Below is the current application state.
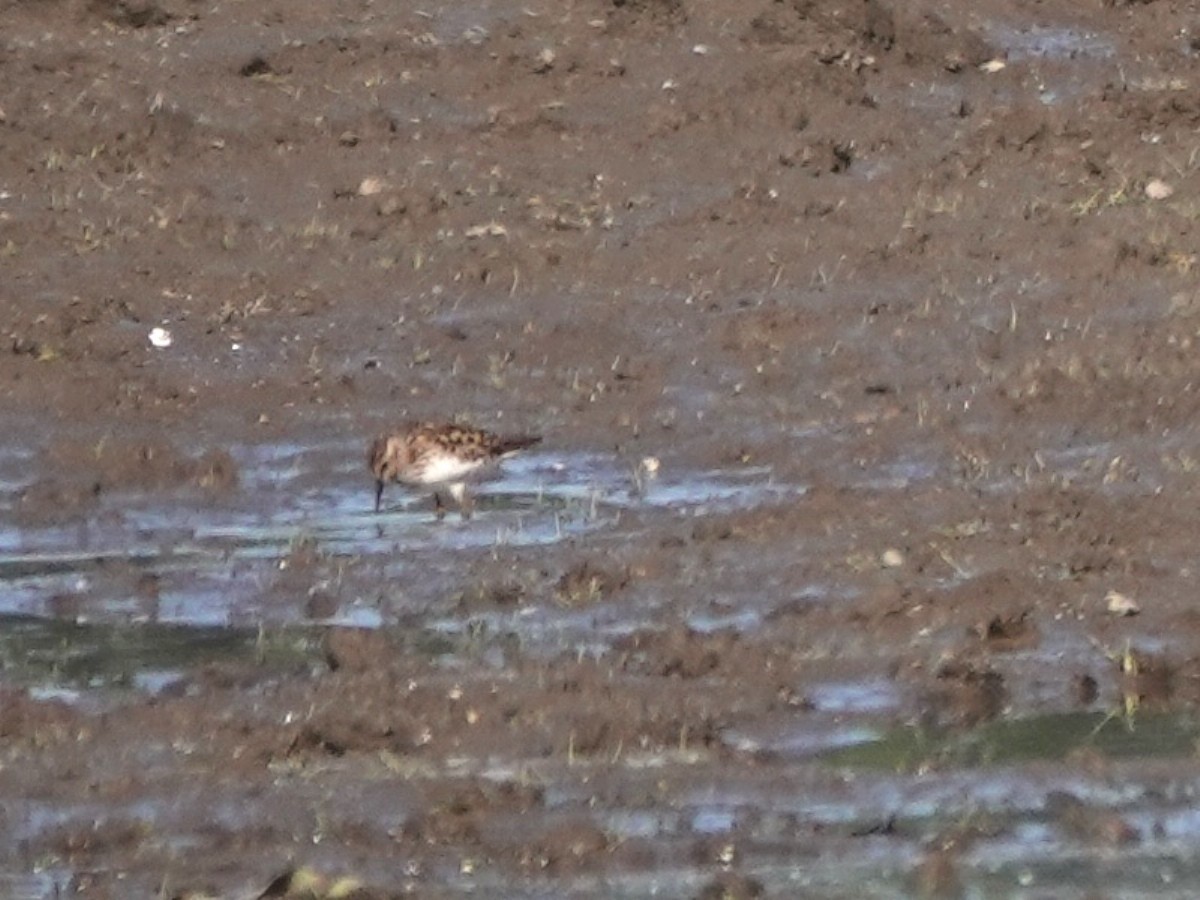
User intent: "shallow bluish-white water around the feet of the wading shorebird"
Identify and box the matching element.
[0,443,802,625]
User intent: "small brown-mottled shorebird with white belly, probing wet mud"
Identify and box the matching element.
[367,422,541,518]
